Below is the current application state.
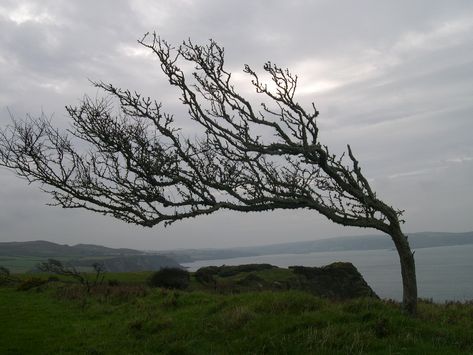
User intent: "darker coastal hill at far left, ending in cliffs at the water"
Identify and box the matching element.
[0,240,181,272]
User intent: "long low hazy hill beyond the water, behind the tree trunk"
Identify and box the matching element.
[160,232,473,263]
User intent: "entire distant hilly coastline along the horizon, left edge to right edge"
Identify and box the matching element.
[0,232,473,272]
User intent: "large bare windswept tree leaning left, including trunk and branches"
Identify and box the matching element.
[0,34,417,314]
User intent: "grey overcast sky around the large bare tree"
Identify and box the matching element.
[0,0,473,250]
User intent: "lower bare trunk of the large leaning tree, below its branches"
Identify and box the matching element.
[390,228,417,315]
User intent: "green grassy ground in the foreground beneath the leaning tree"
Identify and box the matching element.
[0,270,473,354]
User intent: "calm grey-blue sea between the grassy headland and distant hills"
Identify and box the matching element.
[182,244,473,303]
